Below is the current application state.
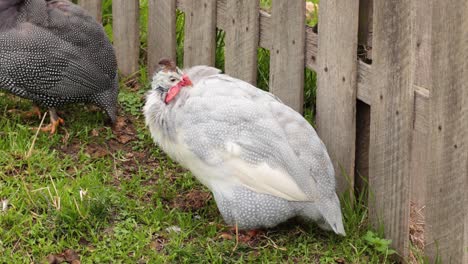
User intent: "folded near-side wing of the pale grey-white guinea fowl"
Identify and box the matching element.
[177,85,318,201]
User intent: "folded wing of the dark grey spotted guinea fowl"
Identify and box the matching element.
[0,23,112,97]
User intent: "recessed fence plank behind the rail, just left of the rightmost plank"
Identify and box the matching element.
[411,0,432,207]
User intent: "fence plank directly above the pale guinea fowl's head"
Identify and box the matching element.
[148,0,177,74]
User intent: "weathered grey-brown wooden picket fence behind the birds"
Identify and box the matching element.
[80,0,468,263]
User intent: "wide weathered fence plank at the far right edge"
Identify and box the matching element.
[425,0,468,263]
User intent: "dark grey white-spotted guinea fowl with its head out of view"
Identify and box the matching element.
[0,0,118,133]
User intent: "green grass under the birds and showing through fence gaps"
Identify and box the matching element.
[0,0,402,263]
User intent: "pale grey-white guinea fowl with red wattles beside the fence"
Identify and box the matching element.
[143,60,345,235]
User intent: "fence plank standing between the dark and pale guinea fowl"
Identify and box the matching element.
[112,0,140,75]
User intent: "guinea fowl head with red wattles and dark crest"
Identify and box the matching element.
[151,59,192,104]
